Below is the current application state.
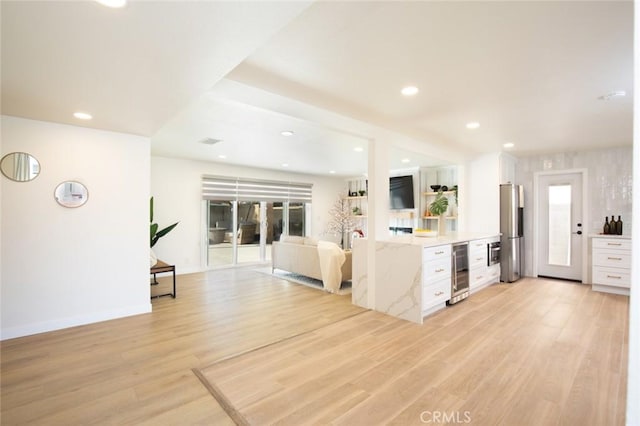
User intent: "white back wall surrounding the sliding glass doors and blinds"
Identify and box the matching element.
[151,156,347,274]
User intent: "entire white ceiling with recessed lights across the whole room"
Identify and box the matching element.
[1,1,633,175]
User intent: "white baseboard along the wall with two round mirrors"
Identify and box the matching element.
[0,302,151,340]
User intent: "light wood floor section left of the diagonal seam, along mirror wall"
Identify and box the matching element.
[0,269,363,425]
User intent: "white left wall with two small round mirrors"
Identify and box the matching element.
[0,116,151,339]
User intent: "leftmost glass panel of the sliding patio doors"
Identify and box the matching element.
[208,201,233,266]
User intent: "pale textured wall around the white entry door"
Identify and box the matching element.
[516,146,633,276]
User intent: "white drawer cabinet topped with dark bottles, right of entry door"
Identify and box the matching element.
[591,235,631,295]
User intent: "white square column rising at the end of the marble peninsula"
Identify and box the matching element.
[367,140,389,309]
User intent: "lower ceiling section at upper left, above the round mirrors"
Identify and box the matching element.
[0,0,309,136]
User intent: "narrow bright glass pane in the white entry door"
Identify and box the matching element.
[549,185,571,266]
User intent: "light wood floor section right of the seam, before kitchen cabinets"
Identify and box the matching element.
[200,280,627,426]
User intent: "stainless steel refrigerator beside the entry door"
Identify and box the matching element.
[500,183,524,283]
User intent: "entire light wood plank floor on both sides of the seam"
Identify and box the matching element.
[0,270,628,425]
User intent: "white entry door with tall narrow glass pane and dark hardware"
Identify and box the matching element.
[537,172,586,281]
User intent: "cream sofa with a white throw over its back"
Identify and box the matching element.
[271,235,351,287]
